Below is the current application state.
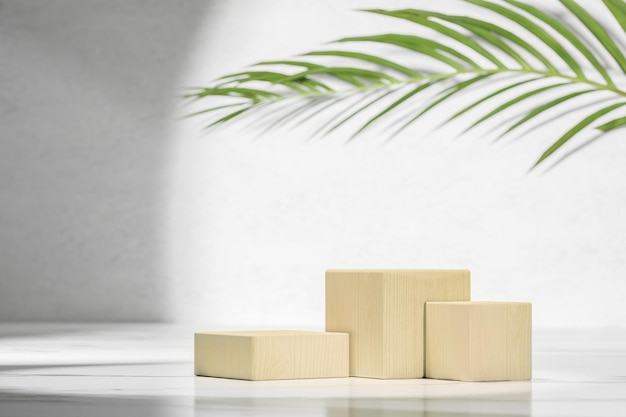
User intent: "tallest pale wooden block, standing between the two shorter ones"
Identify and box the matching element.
[326,269,470,379]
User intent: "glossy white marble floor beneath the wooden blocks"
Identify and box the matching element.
[0,324,626,417]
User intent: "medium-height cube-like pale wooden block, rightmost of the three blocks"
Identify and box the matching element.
[426,302,532,381]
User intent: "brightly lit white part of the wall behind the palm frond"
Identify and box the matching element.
[165,0,626,328]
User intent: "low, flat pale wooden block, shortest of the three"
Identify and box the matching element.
[194,330,349,381]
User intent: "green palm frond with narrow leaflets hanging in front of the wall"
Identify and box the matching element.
[184,0,626,166]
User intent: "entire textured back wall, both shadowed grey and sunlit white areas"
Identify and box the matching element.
[0,0,626,328]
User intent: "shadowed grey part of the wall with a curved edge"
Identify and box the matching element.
[0,0,206,321]
